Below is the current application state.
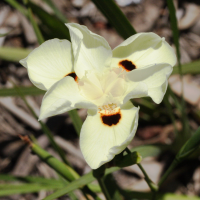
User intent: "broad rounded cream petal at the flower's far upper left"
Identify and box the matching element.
[20,39,73,90]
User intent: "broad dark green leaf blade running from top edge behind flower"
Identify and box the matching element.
[92,0,136,39]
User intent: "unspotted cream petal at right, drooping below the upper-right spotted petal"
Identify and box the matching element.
[127,63,173,104]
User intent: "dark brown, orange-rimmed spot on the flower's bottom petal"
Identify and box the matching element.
[101,111,121,126]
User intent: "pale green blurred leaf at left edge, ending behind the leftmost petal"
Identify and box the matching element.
[0,47,31,62]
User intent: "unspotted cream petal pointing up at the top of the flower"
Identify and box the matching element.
[66,23,112,78]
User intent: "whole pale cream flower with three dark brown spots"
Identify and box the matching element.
[20,23,176,169]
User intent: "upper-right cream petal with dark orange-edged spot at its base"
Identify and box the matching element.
[112,33,176,71]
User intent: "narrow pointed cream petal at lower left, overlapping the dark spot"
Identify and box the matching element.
[39,76,96,120]
